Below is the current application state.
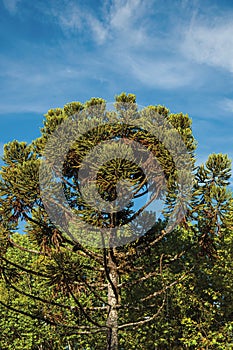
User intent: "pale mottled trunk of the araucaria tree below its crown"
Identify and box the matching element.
[107,250,119,350]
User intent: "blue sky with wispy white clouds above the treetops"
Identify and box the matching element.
[0,0,233,182]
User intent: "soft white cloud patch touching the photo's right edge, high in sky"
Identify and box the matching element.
[181,16,233,73]
